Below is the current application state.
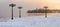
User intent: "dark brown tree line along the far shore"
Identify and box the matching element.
[27,9,60,13]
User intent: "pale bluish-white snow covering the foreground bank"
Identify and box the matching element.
[0,15,60,27]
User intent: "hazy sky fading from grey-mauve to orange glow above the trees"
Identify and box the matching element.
[0,0,60,17]
